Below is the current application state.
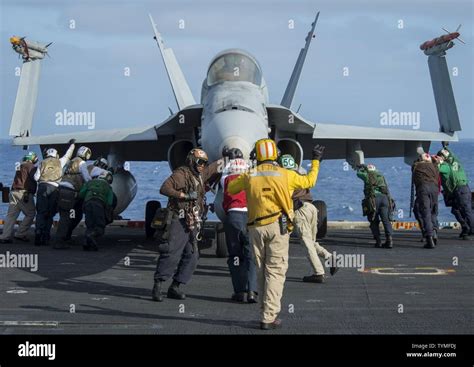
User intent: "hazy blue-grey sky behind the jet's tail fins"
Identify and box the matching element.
[0,0,474,138]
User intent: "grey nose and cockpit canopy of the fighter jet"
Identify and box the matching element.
[201,50,268,161]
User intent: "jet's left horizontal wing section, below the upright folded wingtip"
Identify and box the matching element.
[13,105,202,161]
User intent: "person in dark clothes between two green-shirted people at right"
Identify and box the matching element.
[412,153,439,249]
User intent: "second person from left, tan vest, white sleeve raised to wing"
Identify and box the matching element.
[34,139,75,246]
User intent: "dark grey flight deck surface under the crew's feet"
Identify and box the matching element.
[0,228,474,334]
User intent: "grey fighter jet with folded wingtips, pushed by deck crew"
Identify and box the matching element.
[10,12,461,253]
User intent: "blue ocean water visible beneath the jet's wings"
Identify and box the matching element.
[0,140,474,221]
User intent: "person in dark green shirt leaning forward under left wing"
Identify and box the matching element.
[79,172,114,251]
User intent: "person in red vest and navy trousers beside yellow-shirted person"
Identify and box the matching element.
[221,148,257,303]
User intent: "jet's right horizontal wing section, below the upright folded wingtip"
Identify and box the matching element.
[267,105,458,163]
